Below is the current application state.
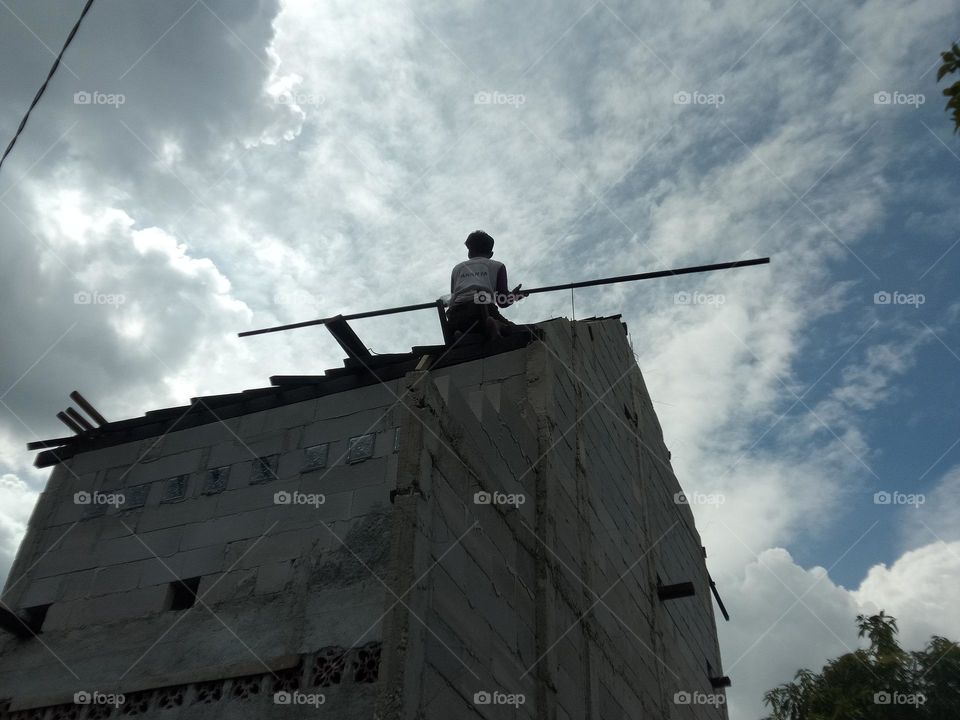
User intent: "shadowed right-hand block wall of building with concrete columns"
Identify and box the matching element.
[377,320,726,720]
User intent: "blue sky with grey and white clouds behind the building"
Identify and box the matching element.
[0,0,960,720]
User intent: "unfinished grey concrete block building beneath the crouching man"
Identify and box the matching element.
[0,317,728,720]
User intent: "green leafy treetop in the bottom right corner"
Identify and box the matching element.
[763,610,960,720]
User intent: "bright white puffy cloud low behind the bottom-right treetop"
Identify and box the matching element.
[719,542,960,720]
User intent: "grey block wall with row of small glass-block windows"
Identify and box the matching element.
[0,382,398,718]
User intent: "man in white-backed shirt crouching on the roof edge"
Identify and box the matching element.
[447,230,525,337]
